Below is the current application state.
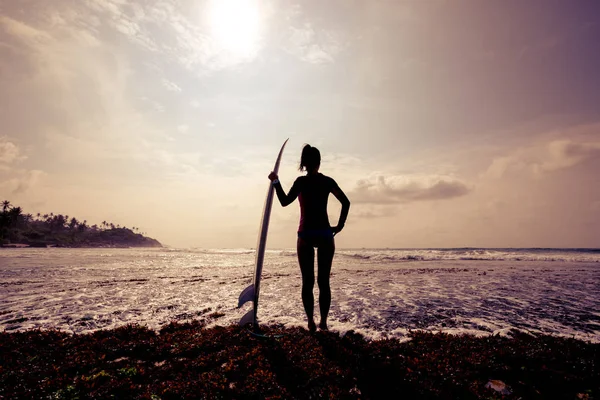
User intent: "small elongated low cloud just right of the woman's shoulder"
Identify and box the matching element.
[349,175,471,204]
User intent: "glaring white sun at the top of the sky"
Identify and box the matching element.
[208,0,260,57]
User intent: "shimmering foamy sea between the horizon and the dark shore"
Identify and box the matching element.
[0,248,600,342]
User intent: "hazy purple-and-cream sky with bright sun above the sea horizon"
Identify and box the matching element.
[0,0,600,248]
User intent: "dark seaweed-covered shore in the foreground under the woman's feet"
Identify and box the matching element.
[0,321,600,399]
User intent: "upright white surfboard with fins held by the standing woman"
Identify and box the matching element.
[238,139,289,330]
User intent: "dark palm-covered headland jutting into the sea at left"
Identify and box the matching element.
[0,200,162,247]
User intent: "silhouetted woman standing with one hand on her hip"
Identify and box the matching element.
[269,144,350,332]
